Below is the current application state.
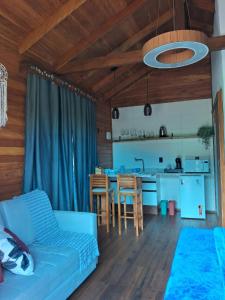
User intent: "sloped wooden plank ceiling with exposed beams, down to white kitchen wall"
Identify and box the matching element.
[0,0,215,106]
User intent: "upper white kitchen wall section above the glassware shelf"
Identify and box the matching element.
[112,99,212,138]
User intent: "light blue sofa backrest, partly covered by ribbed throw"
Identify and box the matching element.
[0,190,59,245]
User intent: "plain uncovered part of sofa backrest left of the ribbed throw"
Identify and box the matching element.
[0,197,34,245]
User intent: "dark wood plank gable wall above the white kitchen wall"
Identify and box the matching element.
[111,59,212,107]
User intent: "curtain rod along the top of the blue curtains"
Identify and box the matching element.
[27,65,97,102]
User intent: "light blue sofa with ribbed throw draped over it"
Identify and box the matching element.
[0,190,99,300]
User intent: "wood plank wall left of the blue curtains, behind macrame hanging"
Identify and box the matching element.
[0,37,26,200]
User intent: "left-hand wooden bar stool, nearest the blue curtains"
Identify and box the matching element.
[90,174,115,232]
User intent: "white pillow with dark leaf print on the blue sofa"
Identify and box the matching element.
[0,226,34,276]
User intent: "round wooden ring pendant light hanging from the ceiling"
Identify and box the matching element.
[143,30,209,69]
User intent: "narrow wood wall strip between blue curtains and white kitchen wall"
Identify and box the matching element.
[96,99,112,168]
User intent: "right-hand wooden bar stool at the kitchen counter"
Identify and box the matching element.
[117,175,143,236]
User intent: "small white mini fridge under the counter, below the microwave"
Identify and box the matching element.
[179,175,205,219]
